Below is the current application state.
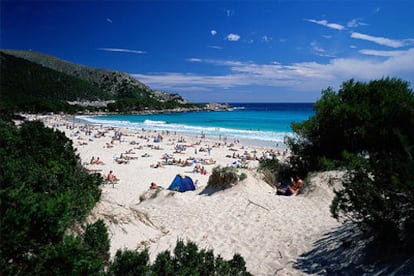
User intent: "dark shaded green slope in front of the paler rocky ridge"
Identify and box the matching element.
[0,52,111,111]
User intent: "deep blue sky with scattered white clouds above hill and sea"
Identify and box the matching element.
[0,0,414,102]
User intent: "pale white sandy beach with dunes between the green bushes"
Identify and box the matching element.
[29,116,341,275]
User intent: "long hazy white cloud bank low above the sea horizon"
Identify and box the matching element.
[132,48,414,92]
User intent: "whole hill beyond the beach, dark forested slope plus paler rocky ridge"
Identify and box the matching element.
[0,50,194,112]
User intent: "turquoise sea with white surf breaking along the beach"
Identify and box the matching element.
[77,103,314,147]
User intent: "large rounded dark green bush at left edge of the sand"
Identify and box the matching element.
[0,122,101,274]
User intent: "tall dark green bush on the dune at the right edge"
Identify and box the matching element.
[289,78,414,247]
